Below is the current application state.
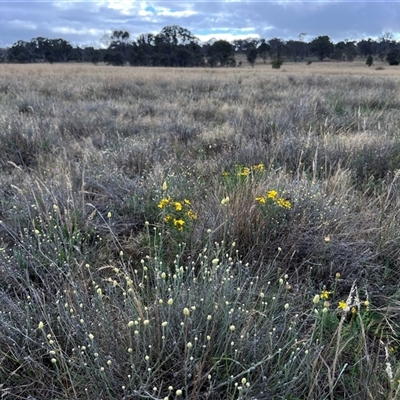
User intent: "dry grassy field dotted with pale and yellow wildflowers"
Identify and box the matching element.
[0,61,400,400]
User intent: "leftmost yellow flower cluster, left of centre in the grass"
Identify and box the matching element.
[157,197,197,231]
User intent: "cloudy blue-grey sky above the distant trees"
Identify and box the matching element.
[0,0,400,47]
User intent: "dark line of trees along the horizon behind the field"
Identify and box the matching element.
[0,25,400,68]
